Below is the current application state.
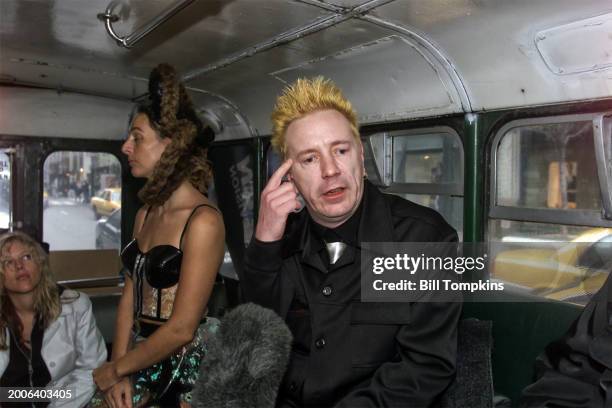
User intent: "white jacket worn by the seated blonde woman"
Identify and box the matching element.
[0,289,106,408]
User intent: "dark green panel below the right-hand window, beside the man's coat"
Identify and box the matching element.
[463,296,582,406]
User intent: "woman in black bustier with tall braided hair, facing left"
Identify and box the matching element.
[93,64,225,407]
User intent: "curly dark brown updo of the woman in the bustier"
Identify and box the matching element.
[135,64,215,206]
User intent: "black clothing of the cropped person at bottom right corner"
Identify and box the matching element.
[521,274,612,408]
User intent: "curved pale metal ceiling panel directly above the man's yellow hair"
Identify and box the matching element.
[190,16,462,134]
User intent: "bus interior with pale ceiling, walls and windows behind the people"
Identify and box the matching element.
[0,0,612,401]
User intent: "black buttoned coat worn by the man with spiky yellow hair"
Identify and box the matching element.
[240,182,461,407]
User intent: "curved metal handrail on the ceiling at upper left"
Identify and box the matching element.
[98,0,195,48]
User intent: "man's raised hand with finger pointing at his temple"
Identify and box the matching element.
[255,159,301,242]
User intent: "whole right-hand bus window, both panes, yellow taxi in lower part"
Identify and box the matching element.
[489,116,612,303]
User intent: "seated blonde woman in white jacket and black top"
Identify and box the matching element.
[0,232,106,407]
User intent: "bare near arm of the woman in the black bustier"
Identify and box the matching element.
[96,207,225,389]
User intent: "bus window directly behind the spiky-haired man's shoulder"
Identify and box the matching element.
[368,128,463,238]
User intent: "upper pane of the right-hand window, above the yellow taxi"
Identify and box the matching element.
[496,121,601,210]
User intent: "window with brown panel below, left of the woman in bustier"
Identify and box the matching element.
[43,151,121,280]
